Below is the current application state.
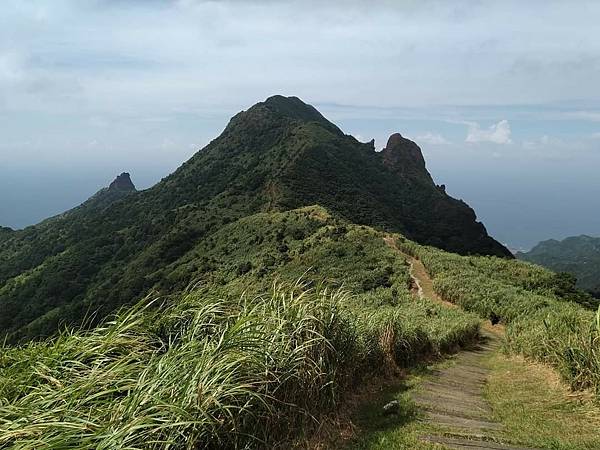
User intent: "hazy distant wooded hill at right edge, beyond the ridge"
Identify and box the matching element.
[517,235,600,295]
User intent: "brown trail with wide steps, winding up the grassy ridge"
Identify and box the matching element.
[385,236,531,450]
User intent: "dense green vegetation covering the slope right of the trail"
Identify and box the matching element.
[400,237,600,395]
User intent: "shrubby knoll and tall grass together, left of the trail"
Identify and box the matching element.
[0,214,479,449]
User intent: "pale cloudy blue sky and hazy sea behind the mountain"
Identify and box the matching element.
[0,0,600,249]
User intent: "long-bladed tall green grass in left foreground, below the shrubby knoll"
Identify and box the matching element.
[0,286,477,450]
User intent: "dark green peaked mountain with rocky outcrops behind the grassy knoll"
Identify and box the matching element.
[0,96,510,339]
